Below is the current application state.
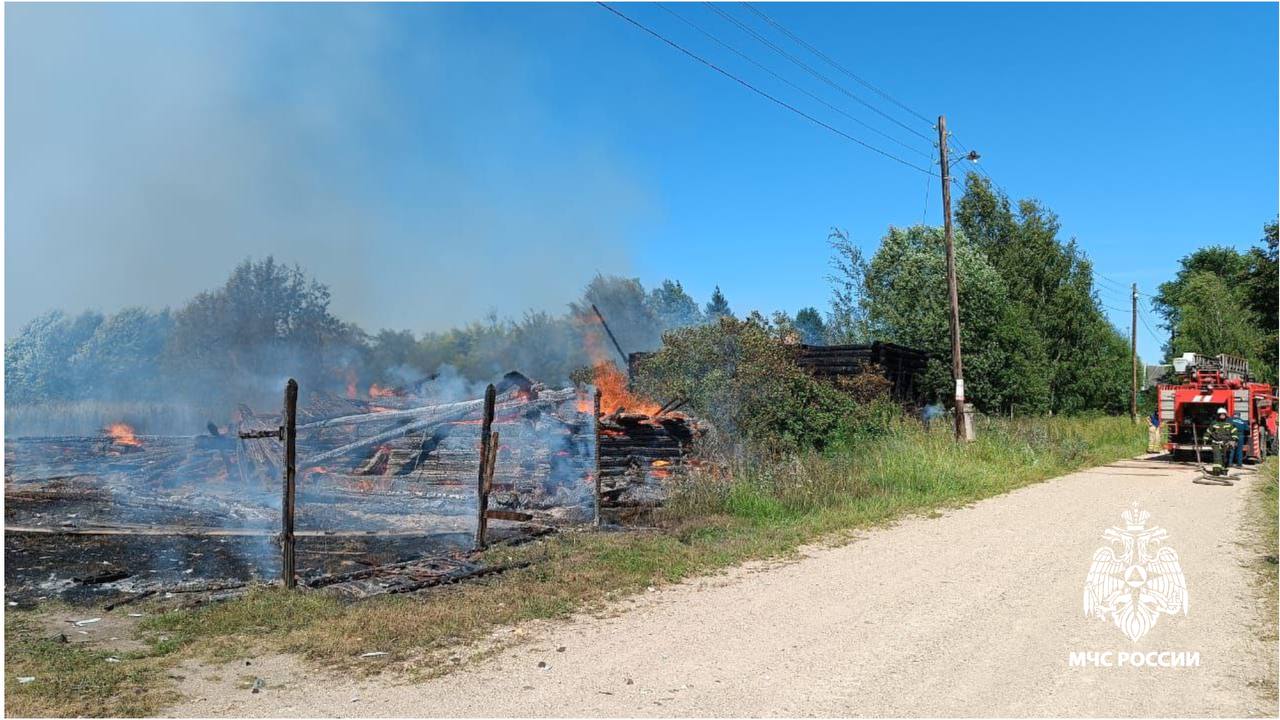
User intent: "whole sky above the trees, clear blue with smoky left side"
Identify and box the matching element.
[5,4,1277,359]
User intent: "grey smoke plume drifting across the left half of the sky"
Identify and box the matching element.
[5,5,646,334]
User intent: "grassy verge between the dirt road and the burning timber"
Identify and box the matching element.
[5,418,1146,715]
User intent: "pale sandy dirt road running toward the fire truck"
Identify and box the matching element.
[170,460,1277,716]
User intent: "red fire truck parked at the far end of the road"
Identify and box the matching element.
[1156,352,1276,461]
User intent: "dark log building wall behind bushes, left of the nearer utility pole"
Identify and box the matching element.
[795,341,928,405]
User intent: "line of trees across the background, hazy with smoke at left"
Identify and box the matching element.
[5,174,1276,425]
